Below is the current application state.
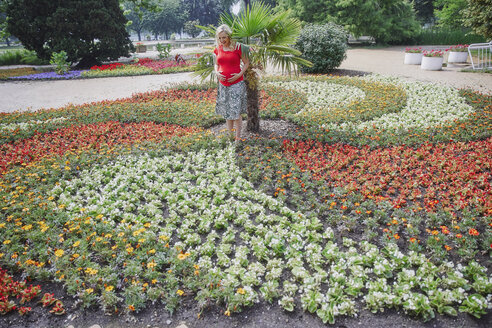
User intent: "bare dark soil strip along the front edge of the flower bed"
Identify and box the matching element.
[0,272,492,328]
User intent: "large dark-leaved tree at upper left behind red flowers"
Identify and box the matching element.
[7,0,134,67]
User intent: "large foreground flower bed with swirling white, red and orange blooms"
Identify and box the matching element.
[0,75,492,323]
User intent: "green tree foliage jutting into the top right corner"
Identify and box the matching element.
[463,0,492,40]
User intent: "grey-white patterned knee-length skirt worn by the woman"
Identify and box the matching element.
[215,81,247,120]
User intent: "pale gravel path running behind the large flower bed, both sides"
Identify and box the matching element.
[0,46,492,112]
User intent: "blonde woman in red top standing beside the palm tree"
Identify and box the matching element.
[214,25,249,141]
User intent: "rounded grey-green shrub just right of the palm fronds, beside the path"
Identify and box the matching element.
[296,23,348,73]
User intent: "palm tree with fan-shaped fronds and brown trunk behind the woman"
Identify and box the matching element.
[196,2,312,132]
